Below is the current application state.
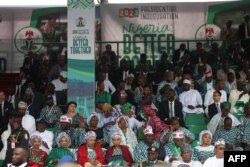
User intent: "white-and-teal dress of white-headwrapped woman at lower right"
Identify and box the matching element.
[194,145,214,162]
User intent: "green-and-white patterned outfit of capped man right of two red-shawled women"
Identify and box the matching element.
[134,141,160,162]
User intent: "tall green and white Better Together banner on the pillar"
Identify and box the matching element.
[68,0,95,118]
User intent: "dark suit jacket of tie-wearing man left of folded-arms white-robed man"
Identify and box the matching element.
[158,100,185,127]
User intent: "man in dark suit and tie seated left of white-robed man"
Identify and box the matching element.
[158,88,185,126]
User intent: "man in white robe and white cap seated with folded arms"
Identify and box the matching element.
[179,79,204,115]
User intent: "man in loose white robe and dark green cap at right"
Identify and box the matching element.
[207,102,241,134]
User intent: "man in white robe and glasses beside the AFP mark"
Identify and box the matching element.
[202,139,226,167]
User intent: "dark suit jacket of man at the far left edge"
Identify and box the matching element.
[0,101,13,134]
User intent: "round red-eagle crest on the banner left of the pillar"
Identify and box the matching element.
[14,27,43,54]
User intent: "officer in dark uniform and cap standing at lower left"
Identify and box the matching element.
[3,110,29,167]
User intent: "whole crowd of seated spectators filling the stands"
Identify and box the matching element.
[0,42,250,167]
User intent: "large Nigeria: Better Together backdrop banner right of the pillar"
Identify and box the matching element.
[101,1,250,65]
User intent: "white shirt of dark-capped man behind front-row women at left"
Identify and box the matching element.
[31,130,54,153]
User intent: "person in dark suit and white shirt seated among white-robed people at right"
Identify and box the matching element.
[205,90,221,119]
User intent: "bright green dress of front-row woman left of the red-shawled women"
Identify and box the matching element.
[45,147,73,167]
